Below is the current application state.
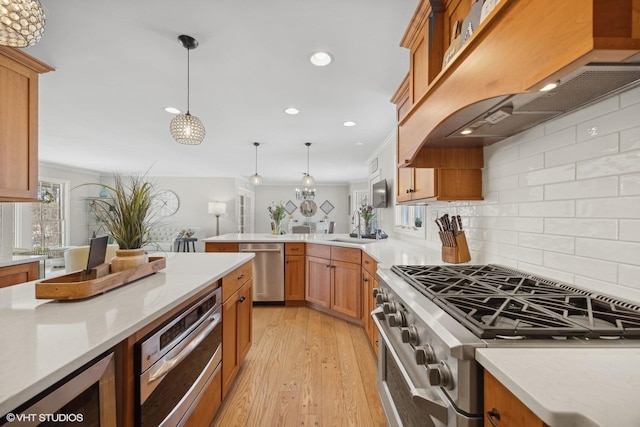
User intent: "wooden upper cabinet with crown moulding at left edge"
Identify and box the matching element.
[0,46,53,202]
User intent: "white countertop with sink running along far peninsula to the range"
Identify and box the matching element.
[203,233,442,268]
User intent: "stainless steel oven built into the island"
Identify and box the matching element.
[135,287,222,427]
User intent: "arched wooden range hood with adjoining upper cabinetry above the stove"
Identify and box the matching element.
[393,0,640,167]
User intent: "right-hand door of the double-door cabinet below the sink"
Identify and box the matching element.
[331,261,362,319]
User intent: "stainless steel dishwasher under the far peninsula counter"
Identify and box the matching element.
[240,243,284,303]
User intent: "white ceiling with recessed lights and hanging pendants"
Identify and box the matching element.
[25,0,418,184]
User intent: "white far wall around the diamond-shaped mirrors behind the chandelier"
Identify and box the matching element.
[254,185,351,233]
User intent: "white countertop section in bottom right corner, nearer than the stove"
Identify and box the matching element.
[476,348,640,427]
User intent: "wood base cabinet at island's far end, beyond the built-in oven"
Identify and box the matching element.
[221,262,253,399]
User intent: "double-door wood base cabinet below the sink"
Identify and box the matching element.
[305,244,362,320]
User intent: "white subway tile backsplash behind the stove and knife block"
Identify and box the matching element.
[390,89,640,302]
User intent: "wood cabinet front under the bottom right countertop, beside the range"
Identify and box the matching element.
[484,371,548,427]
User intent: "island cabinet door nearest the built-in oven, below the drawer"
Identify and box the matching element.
[222,293,239,399]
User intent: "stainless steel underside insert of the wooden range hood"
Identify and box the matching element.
[445,63,640,145]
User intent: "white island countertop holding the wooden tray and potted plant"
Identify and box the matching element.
[0,253,254,415]
